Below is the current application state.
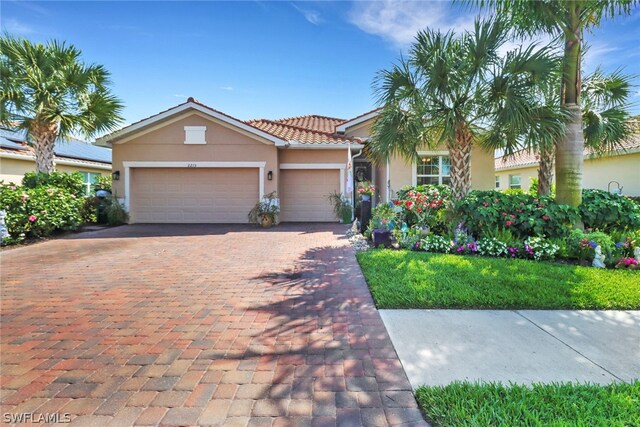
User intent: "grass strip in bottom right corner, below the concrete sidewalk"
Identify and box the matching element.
[416,381,640,427]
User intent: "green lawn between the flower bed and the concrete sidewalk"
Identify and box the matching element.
[357,249,640,310]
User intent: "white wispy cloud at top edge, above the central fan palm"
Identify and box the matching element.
[348,0,475,47]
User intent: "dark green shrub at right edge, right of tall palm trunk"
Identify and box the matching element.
[579,190,640,232]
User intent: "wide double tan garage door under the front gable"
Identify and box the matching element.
[131,168,259,223]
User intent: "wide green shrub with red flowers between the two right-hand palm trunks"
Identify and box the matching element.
[456,191,579,239]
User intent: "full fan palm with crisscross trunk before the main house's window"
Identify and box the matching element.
[367,20,563,199]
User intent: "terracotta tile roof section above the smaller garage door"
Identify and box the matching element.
[246,116,362,144]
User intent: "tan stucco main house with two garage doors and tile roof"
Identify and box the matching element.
[96,98,494,223]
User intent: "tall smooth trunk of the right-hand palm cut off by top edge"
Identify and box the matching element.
[556,2,584,206]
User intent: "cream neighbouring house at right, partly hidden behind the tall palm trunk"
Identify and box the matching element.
[495,135,640,197]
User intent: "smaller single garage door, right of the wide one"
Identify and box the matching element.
[280,169,340,222]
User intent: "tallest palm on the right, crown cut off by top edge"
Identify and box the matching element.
[469,0,637,206]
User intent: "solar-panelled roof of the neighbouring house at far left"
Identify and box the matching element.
[0,129,111,165]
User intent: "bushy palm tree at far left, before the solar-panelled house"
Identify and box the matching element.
[0,36,122,173]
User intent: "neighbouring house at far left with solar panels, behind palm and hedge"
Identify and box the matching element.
[0,129,111,194]
